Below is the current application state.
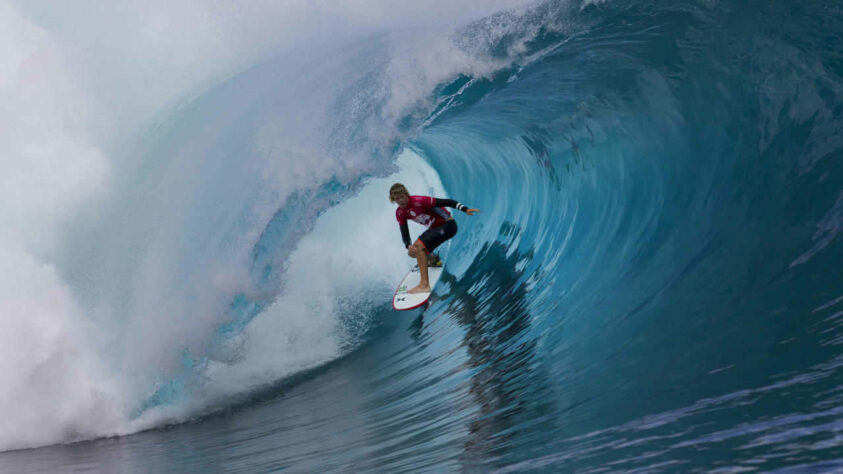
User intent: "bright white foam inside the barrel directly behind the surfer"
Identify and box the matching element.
[191,151,445,406]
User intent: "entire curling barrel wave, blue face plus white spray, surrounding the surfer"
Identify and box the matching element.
[0,1,843,470]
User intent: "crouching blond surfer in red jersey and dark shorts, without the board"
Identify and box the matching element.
[389,183,480,293]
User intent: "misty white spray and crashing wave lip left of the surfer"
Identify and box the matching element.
[0,2,540,449]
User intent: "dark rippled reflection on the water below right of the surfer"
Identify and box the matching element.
[437,224,556,470]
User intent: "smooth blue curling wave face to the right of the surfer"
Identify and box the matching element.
[412,2,843,470]
